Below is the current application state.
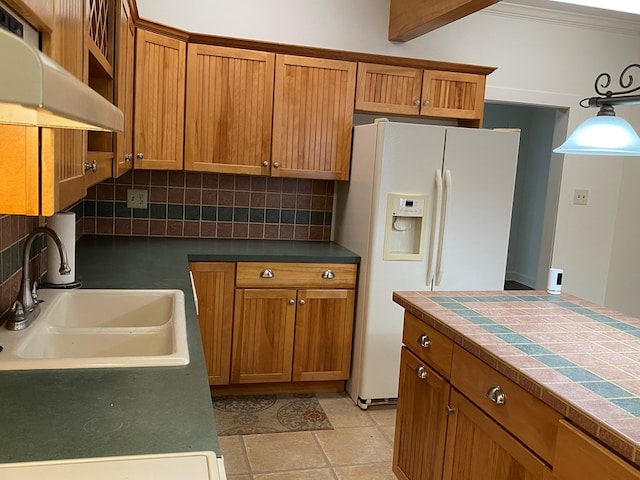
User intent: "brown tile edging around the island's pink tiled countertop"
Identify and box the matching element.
[393,291,640,468]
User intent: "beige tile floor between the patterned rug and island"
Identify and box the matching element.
[220,393,396,480]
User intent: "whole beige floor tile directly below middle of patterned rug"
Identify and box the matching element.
[243,430,333,474]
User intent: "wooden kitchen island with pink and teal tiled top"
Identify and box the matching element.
[393,291,640,480]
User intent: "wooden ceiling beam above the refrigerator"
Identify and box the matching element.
[389,0,500,42]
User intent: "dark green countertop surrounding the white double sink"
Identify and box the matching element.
[0,235,360,462]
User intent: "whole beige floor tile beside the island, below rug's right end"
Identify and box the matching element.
[314,427,393,466]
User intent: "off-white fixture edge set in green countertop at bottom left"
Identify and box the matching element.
[0,452,226,480]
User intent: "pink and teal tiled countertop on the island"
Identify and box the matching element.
[393,291,640,467]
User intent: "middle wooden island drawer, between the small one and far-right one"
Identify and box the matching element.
[451,345,562,465]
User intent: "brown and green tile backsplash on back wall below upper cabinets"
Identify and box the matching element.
[82,170,334,241]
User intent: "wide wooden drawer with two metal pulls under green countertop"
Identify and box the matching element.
[236,262,357,288]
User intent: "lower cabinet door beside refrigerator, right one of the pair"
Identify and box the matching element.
[293,290,354,381]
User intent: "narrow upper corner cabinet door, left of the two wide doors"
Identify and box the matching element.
[133,30,186,170]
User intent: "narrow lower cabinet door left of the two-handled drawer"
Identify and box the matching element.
[189,262,236,385]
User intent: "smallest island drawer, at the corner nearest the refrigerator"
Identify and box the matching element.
[402,312,453,379]
